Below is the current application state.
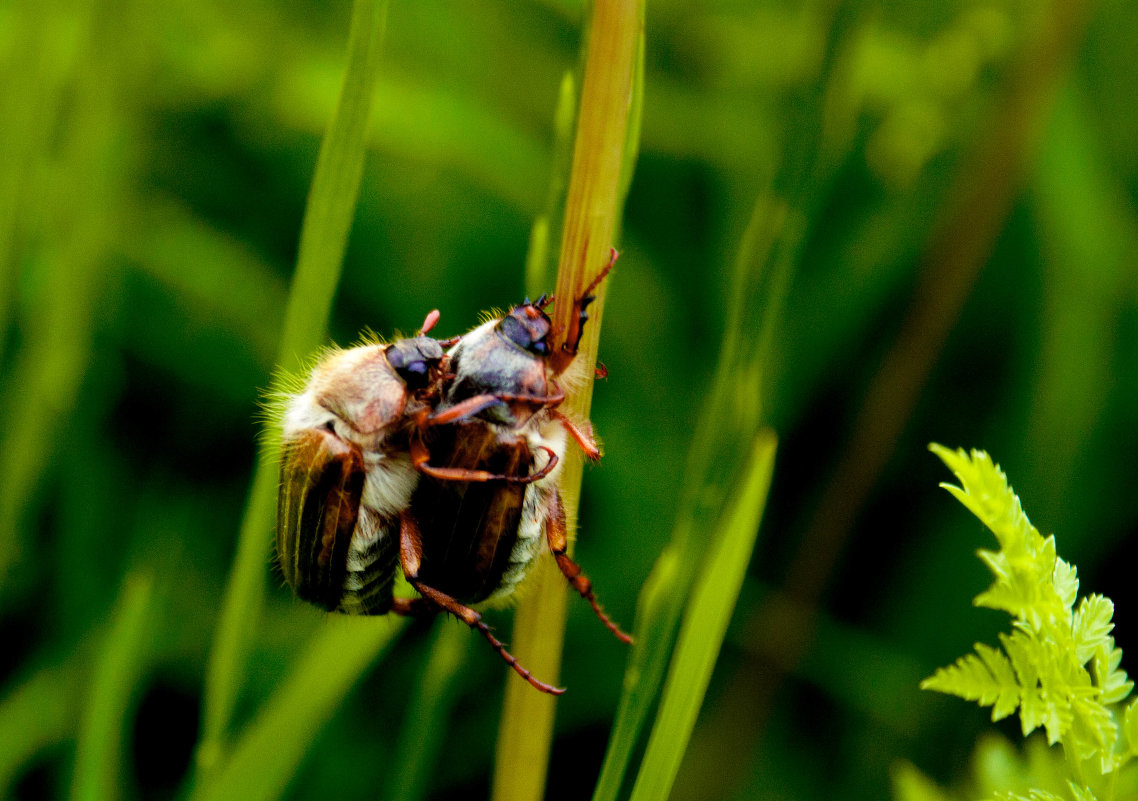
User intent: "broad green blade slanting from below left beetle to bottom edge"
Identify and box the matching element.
[190,616,404,801]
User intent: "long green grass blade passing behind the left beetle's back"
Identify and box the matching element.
[197,0,388,778]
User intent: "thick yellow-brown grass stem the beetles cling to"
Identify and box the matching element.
[493,0,644,801]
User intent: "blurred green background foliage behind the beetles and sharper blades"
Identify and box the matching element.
[0,0,1138,799]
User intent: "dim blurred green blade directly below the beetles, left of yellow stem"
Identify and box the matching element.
[381,625,475,801]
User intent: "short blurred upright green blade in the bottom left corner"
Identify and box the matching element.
[71,576,154,801]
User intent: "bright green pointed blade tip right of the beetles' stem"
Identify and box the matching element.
[632,429,777,801]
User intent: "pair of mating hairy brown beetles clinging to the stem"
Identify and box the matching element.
[277,250,630,694]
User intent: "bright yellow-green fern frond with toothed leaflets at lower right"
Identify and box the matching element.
[921,445,1138,782]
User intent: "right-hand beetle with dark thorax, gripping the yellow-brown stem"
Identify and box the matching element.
[399,250,632,694]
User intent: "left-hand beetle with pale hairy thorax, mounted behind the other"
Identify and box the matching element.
[277,311,452,614]
